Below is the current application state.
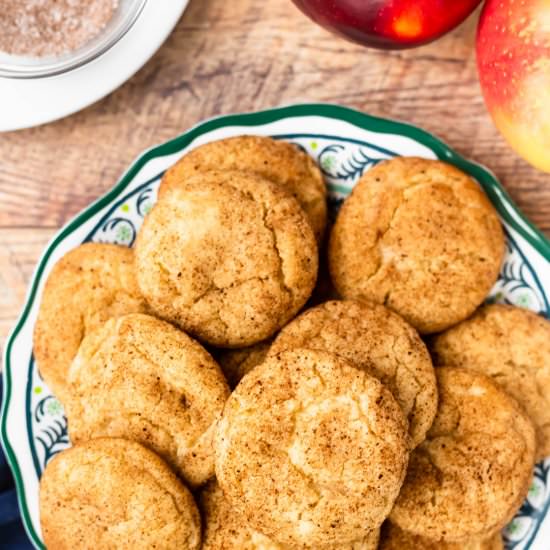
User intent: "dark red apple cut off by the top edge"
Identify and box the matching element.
[293,0,480,50]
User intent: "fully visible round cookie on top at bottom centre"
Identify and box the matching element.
[215,350,409,548]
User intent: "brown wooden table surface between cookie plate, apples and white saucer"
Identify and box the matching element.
[0,0,550,352]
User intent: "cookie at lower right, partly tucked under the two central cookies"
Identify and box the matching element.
[390,367,535,542]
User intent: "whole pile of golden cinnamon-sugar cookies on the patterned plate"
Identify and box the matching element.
[34,136,550,550]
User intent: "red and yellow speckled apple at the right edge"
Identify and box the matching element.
[476,0,550,172]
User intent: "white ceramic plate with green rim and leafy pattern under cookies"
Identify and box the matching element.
[1,105,550,550]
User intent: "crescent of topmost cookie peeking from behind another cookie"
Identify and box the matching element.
[159,136,327,241]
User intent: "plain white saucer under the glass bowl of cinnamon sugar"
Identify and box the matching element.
[0,0,189,132]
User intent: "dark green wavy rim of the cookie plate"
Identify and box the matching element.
[0,103,550,548]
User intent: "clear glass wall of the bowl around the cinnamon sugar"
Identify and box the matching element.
[0,0,147,79]
